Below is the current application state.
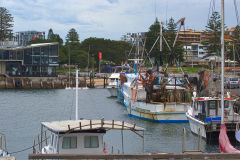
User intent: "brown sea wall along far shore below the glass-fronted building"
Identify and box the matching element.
[0,73,110,89]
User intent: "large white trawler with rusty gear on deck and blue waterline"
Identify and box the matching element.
[123,71,191,123]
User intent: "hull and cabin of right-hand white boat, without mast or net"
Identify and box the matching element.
[186,95,240,142]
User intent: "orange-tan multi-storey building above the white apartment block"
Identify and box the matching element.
[178,29,203,44]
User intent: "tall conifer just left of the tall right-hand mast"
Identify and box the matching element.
[203,12,221,56]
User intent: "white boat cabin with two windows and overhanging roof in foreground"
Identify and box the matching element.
[41,119,144,154]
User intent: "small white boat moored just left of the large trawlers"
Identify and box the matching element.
[107,73,120,97]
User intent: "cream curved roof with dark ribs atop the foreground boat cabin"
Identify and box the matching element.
[41,119,144,132]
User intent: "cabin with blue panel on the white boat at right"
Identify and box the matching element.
[191,97,238,123]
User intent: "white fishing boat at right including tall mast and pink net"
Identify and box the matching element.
[186,0,240,144]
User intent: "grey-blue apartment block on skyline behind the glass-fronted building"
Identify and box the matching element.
[15,31,45,46]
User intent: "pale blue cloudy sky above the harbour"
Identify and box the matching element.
[0,0,240,41]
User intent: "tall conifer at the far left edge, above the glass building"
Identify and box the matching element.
[0,7,13,41]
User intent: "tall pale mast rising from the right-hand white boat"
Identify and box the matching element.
[221,0,224,124]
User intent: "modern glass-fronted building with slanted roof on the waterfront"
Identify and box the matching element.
[0,42,59,77]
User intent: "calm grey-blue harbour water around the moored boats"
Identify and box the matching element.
[0,89,232,160]
